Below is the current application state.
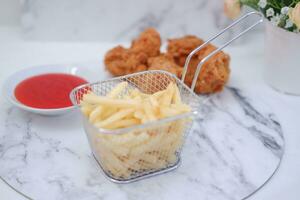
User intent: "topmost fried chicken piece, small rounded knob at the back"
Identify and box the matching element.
[130,28,161,57]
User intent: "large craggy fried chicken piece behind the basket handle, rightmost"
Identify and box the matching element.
[167,36,230,94]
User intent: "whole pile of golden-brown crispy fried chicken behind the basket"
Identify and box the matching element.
[104,28,230,94]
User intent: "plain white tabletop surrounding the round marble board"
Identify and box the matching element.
[0,27,300,199]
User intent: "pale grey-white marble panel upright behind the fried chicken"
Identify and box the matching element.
[21,0,258,41]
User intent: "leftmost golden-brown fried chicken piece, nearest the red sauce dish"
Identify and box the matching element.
[104,46,147,76]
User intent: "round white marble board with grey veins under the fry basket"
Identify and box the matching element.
[0,69,284,200]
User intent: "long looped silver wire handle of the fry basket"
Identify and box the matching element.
[181,12,263,91]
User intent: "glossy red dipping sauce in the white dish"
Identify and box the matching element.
[15,73,87,109]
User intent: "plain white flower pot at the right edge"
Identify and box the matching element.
[264,21,300,95]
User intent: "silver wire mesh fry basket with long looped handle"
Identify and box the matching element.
[70,12,262,183]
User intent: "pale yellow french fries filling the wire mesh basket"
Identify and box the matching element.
[81,82,191,178]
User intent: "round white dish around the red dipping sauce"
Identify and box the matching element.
[3,63,109,115]
